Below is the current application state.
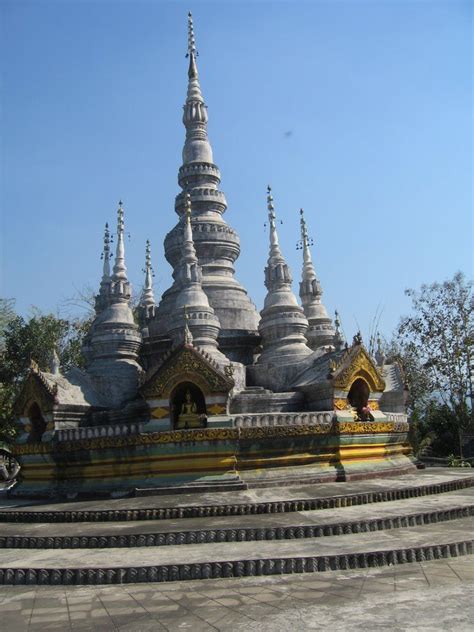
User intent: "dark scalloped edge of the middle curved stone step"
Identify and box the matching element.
[0,504,474,549]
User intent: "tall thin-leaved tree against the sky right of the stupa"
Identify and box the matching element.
[396,272,474,456]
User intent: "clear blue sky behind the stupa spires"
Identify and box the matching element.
[0,0,473,344]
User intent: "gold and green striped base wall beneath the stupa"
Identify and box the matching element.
[12,421,415,498]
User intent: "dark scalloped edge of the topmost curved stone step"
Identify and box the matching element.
[0,477,474,523]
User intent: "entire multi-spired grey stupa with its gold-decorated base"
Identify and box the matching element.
[9,16,414,497]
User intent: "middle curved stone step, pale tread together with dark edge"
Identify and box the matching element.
[0,487,474,549]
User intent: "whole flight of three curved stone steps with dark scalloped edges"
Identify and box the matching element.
[0,468,474,584]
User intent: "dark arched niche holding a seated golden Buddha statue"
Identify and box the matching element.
[170,382,207,430]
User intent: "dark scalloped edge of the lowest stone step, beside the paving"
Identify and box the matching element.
[0,539,473,585]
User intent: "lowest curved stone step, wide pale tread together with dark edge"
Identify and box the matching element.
[0,518,474,584]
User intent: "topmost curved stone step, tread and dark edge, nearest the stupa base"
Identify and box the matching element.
[0,468,474,523]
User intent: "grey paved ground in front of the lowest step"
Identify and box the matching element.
[0,551,474,632]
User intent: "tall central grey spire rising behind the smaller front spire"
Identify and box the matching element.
[145,9,258,363]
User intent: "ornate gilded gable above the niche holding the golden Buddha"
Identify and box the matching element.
[140,347,234,399]
